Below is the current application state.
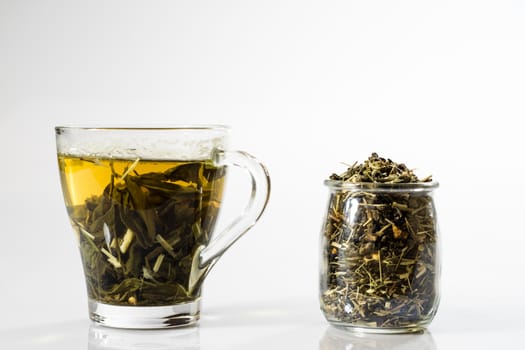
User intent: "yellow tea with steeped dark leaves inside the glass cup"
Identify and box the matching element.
[58,155,225,306]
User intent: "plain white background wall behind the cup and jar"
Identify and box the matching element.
[0,0,525,342]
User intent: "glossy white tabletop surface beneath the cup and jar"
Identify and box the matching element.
[0,300,525,350]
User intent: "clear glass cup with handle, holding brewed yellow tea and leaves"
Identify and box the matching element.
[55,126,270,329]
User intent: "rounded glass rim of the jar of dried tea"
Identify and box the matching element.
[324,179,439,192]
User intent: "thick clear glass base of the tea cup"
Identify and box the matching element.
[88,300,200,329]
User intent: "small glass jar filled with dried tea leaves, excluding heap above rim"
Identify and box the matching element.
[320,180,441,333]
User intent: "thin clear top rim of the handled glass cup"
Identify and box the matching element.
[55,124,230,132]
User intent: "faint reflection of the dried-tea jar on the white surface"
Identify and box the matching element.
[319,326,437,350]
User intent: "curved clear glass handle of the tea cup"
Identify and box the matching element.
[199,150,270,270]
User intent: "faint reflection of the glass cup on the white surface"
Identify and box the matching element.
[88,324,200,350]
